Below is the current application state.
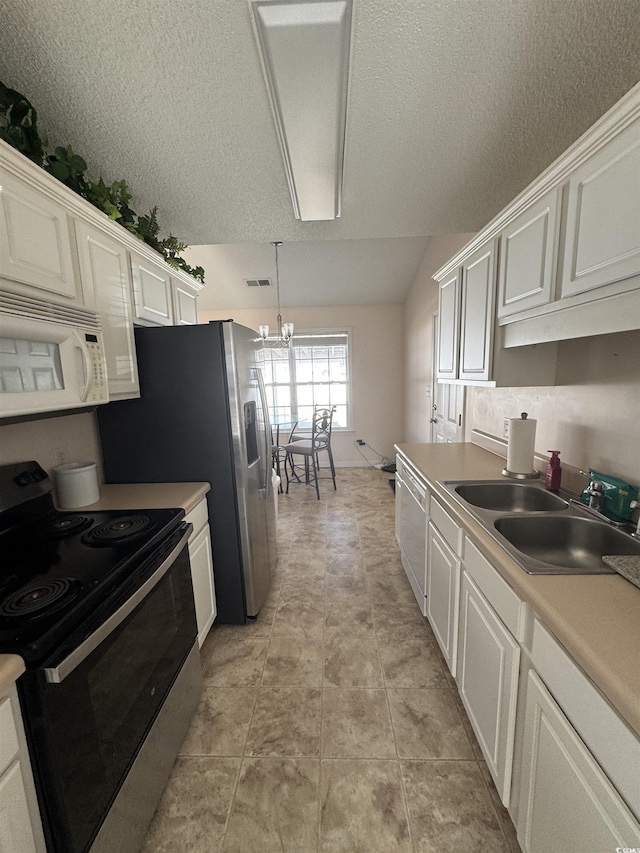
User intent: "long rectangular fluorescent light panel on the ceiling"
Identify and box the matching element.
[250,0,352,221]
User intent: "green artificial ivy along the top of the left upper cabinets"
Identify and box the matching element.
[0,81,204,283]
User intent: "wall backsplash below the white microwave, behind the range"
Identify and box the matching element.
[0,413,103,482]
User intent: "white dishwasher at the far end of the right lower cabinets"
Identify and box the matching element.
[396,465,429,616]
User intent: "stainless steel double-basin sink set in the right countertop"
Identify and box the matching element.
[441,480,640,575]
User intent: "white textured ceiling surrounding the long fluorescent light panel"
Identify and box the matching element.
[0,0,640,301]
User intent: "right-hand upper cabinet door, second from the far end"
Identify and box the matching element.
[458,240,497,380]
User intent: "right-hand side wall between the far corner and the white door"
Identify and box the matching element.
[404,234,474,442]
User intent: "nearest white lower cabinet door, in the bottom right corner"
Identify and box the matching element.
[518,670,640,853]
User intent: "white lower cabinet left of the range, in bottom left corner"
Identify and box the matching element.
[0,687,45,853]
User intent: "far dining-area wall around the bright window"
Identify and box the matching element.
[199,305,404,465]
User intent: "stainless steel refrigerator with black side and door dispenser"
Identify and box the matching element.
[98,320,277,624]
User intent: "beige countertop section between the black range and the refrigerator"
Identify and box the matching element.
[65,483,211,513]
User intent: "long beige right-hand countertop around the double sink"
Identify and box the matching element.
[397,444,640,735]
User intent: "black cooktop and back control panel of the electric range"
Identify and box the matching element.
[0,462,184,667]
